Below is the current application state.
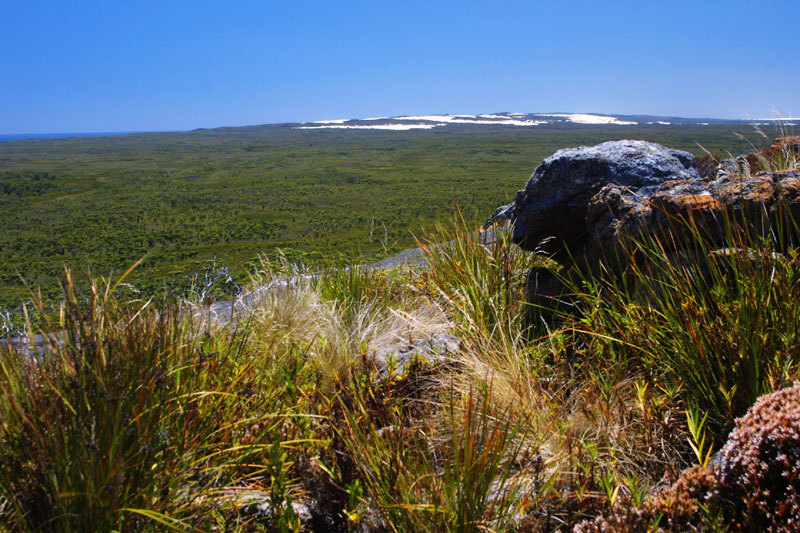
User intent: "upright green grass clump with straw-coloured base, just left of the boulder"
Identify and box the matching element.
[423,217,560,466]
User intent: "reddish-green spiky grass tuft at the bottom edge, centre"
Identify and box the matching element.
[343,382,526,531]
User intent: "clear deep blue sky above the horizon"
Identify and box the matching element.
[0,0,800,133]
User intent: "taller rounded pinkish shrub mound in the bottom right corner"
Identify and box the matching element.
[717,383,800,531]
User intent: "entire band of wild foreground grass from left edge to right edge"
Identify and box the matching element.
[0,139,800,531]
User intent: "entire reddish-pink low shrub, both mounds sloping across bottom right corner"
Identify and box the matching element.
[575,382,800,533]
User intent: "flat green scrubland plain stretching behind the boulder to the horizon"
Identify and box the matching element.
[0,120,764,308]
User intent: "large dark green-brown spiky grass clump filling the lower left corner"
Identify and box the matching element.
[0,274,310,531]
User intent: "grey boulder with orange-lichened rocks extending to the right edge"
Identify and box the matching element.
[489,137,800,266]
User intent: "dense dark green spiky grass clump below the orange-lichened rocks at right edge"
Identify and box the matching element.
[578,206,800,438]
